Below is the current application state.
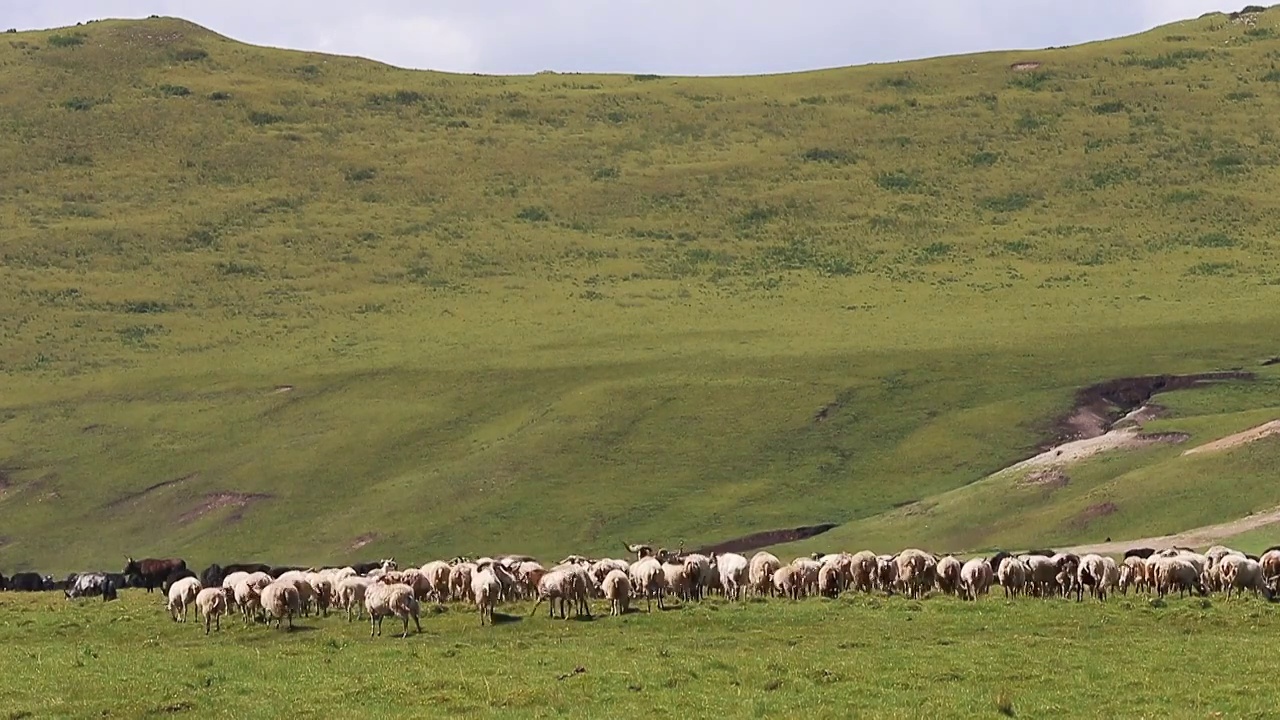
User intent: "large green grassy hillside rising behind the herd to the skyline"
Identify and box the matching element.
[0,12,1280,571]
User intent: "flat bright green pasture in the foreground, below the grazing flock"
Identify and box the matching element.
[0,589,1277,717]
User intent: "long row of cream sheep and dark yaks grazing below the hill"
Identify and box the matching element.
[0,544,1280,635]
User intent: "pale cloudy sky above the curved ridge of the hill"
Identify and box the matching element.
[0,0,1228,74]
